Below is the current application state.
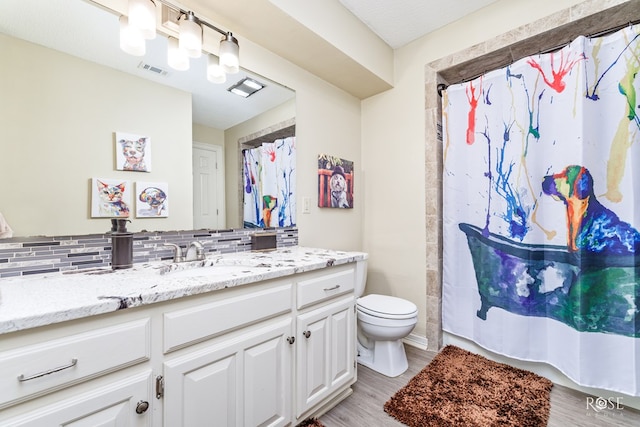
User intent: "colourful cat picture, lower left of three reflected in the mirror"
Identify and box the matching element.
[91,178,133,218]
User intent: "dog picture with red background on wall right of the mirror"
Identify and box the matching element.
[318,154,353,209]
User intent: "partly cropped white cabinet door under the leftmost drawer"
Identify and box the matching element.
[0,371,153,427]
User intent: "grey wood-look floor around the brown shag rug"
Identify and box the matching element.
[320,346,640,427]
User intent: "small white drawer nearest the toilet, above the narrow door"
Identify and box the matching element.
[298,266,355,308]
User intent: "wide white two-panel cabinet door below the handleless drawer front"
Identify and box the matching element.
[164,318,293,427]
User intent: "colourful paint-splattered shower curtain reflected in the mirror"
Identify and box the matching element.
[242,137,296,228]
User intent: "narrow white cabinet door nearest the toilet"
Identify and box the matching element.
[296,296,356,417]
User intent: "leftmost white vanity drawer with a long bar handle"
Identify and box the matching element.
[0,319,150,408]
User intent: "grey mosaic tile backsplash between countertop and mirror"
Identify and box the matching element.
[0,227,298,278]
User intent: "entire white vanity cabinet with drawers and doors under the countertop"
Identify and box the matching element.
[0,263,356,427]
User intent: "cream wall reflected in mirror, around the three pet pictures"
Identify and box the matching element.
[0,34,193,236]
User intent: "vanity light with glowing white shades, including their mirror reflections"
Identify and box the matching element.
[120,0,240,84]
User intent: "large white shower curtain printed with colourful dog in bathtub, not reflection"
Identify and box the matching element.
[442,25,640,396]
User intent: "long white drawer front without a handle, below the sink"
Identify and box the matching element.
[164,283,293,353]
